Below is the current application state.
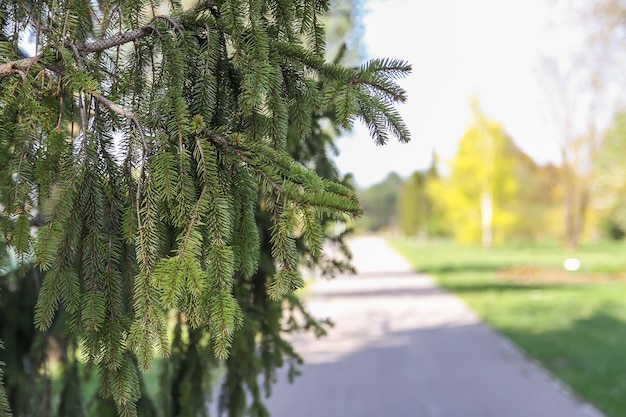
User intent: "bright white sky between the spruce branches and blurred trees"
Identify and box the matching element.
[336,0,580,187]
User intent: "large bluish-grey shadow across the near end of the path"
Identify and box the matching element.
[268,316,594,417]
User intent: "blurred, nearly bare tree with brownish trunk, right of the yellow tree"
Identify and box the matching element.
[538,0,626,247]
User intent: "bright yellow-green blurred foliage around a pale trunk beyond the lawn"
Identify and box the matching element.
[436,112,558,244]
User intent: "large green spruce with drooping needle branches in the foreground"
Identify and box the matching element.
[0,0,410,416]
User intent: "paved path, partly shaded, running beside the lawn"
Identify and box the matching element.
[268,237,601,417]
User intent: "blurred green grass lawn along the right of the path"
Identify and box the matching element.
[390,240,626,417]
